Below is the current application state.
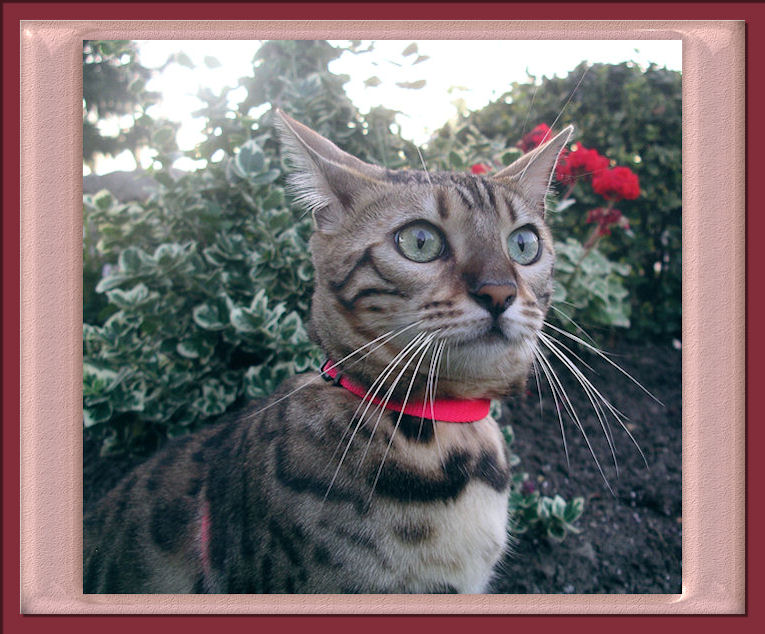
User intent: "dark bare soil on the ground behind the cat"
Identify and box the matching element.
[83,336,682,594]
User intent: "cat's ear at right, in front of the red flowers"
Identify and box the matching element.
[492,126,574,213]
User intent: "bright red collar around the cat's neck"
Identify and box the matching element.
[321,360,491,423]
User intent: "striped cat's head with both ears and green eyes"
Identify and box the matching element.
[276,111,572,398]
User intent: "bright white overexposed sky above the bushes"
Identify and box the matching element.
[88,40,682,173]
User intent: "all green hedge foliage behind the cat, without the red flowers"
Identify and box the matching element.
[83,41,681,452]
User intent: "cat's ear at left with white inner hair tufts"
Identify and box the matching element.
[274,108,384,233]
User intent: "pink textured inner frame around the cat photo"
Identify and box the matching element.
[3,0,751,620]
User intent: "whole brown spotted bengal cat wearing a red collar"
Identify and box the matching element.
[83,107,571,593]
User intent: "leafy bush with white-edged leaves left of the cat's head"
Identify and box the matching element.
[83,41,412,452]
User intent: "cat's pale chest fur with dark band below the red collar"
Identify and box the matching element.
[292,380,509,593]
